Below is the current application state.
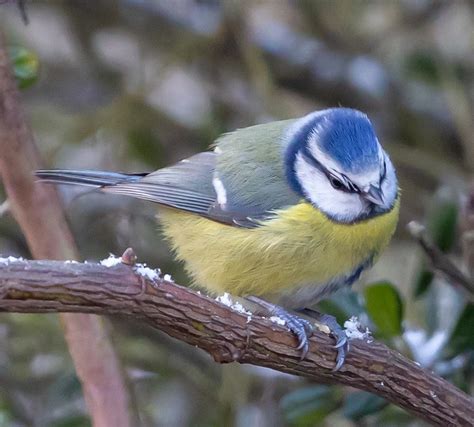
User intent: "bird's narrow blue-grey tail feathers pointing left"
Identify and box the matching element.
[35,169,147,187]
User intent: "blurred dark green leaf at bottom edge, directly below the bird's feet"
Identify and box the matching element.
[280,385,338,427]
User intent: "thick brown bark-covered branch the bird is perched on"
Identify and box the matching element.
[0,261,474,426]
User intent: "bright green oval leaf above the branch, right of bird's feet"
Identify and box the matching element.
[364,282,403,338]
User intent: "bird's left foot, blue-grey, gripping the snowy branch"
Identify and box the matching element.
[247,296,314,360]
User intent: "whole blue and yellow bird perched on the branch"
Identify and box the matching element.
[36,107,400,370]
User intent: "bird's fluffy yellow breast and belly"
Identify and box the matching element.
[159,201,399,297]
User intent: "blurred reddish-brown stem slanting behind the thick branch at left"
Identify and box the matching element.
[0,32,133,427]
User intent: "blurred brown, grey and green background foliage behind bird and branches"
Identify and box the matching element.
[0,0,474,427]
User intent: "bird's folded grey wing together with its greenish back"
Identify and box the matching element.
[102,121,299,228]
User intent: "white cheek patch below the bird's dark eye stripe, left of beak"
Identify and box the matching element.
[295,153,367,222]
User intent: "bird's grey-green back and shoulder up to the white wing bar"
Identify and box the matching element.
[209,120,300,227]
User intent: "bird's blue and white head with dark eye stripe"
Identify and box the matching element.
[285,108,398,223]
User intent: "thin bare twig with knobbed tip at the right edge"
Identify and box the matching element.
[408,221,474,301]
